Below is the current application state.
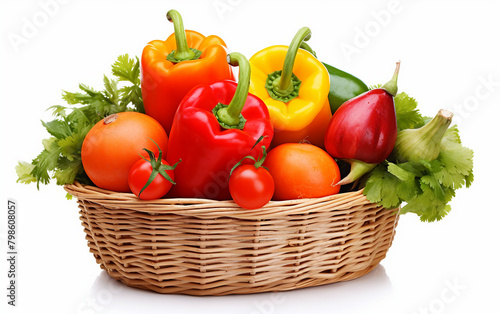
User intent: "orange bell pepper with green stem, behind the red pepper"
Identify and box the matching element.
[141,10,234,134]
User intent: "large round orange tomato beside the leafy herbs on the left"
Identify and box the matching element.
[82,112,168,192]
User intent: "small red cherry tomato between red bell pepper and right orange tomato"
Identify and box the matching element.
[229,165,274,209]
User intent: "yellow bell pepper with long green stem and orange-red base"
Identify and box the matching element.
[249,27,332,147]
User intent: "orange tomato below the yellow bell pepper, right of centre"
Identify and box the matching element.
[264,143,340,200]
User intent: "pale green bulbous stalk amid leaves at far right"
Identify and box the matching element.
[392,109,453,162]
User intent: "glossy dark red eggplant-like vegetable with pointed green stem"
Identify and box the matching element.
[325,62,399,184]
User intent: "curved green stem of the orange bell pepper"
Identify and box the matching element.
[167,10,201,63]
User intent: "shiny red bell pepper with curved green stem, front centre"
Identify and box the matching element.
[167,53,274,200]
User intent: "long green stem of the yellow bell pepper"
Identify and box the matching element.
[266,27,311,102]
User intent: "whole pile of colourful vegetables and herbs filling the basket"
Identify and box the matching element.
[16,10,473,221]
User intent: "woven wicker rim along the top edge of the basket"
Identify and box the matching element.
[64,181,380,219]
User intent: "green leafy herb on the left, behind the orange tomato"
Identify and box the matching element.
[16,54,144,188]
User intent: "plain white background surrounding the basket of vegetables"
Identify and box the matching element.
[0,0,500,314]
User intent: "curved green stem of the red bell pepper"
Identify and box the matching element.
[213,52,250,130]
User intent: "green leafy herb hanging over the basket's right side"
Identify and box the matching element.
[363,93,474,222]
